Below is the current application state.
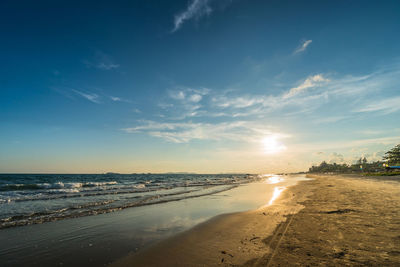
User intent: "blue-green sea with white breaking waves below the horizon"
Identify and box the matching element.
[0,173,265,229]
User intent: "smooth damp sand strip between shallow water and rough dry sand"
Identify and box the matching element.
[110,177,311,266]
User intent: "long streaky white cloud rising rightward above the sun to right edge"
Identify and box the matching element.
[211,70,390,115]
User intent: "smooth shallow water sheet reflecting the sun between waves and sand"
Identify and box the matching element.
[0,175,305,266]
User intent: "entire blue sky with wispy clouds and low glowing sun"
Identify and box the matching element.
[0,0,400,173]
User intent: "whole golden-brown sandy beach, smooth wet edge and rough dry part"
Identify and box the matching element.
[112,176,400,266]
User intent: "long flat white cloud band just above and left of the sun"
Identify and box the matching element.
[122,121,288,143]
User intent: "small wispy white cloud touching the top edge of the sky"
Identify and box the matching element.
[171,0,213,33]
